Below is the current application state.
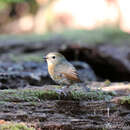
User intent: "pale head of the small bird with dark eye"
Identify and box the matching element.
[44,52,66,65]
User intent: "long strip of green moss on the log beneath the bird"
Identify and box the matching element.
[0,89,113,104]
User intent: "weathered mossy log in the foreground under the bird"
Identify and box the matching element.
[0,81,130,130]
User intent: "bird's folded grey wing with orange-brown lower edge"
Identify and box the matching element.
[54,63,80,82]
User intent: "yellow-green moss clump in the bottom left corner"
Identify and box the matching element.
[0,123,34,130]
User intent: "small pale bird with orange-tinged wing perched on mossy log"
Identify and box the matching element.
[43,52,81,94]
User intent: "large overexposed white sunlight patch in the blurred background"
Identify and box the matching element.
[53,0,118,29]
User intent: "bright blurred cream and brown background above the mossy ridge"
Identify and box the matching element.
[0,0,130,34]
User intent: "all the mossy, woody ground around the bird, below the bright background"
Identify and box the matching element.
[0,28,130,130]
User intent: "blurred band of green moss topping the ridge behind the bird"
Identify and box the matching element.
[0,27,130,44]
